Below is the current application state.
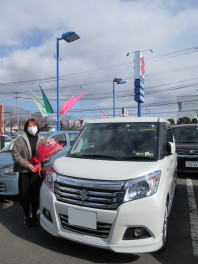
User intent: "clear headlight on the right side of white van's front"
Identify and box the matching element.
[124,171,161,202]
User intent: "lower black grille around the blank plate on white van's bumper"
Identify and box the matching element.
[60,214,111,238]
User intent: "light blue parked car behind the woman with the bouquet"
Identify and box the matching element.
[0,131,79,196]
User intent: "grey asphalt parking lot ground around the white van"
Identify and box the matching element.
[0,175,198,264]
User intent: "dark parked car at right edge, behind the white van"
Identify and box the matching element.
[173,124,198,173]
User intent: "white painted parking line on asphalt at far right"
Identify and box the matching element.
[186,179,198,257]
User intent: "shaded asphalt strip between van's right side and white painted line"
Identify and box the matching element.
[152,175,198,264]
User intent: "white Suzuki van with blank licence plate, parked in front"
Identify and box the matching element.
[40,117,177,253]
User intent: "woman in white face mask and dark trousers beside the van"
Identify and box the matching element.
[12,119,42,228]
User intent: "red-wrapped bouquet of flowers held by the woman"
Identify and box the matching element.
[30,138,63,178]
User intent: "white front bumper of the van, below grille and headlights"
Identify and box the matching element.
[40,183,165,253]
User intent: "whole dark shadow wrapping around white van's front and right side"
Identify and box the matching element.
[0,178,198,264]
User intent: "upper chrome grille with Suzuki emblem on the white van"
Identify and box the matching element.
[54,176,124,210]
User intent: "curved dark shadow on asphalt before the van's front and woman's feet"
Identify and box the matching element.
[0,197,139,263]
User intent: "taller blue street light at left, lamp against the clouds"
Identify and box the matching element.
[56,32,80,131]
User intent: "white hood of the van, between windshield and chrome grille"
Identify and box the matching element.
[53,157,161,181]
